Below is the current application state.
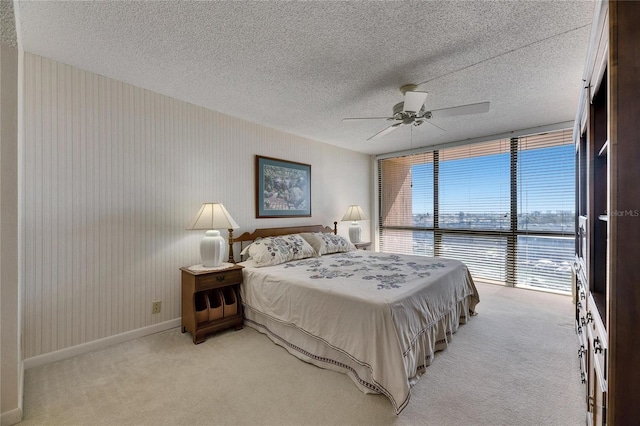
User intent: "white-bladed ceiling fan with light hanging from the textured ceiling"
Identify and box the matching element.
[342,84,489,140]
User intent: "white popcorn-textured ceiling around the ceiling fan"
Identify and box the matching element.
[15,0,594,154]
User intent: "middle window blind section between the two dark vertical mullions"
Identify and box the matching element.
[436,139,511,283]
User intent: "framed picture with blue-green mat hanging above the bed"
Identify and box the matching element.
[256,155,311,218]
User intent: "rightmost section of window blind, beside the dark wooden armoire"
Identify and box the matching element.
[515,130,575,292]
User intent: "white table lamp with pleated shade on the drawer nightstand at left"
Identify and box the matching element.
[187,203,239,267]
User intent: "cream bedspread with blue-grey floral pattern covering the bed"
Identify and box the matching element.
[242,251,479,413]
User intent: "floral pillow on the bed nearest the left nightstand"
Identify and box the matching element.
[241,234,315,266]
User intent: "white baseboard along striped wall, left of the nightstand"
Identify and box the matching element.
[23,318,181,370]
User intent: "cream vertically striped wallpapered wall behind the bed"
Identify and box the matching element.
[20,53,372,358]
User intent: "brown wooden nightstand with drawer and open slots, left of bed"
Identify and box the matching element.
[180,265,243,344]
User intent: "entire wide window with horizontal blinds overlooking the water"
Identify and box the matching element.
[378,130,575,293]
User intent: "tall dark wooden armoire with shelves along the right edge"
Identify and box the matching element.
[574,0,640,425]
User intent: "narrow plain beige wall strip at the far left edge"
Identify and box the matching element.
[0,43,22,425]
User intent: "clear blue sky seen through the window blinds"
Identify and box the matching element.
[411,145,575,229]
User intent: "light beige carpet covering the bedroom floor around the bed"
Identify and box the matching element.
[21,283,585,426]
